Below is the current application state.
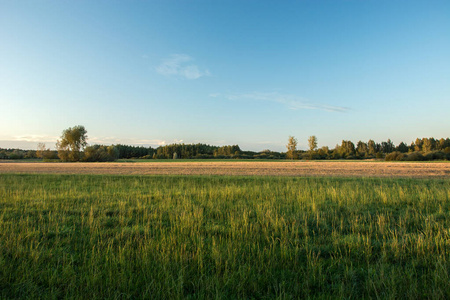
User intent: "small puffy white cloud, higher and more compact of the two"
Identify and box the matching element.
[156,54,211,80]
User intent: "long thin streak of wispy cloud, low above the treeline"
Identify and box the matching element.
[214,92,349,112]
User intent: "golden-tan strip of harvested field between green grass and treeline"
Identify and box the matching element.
[0,161,450,178]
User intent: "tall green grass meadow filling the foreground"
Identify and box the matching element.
[0,174,450,299]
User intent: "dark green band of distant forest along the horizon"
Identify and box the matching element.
[0,136,450,161]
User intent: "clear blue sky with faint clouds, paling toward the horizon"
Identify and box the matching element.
[0,0,450,151]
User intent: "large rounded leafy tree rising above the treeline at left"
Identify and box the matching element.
[56,125,87,161]
